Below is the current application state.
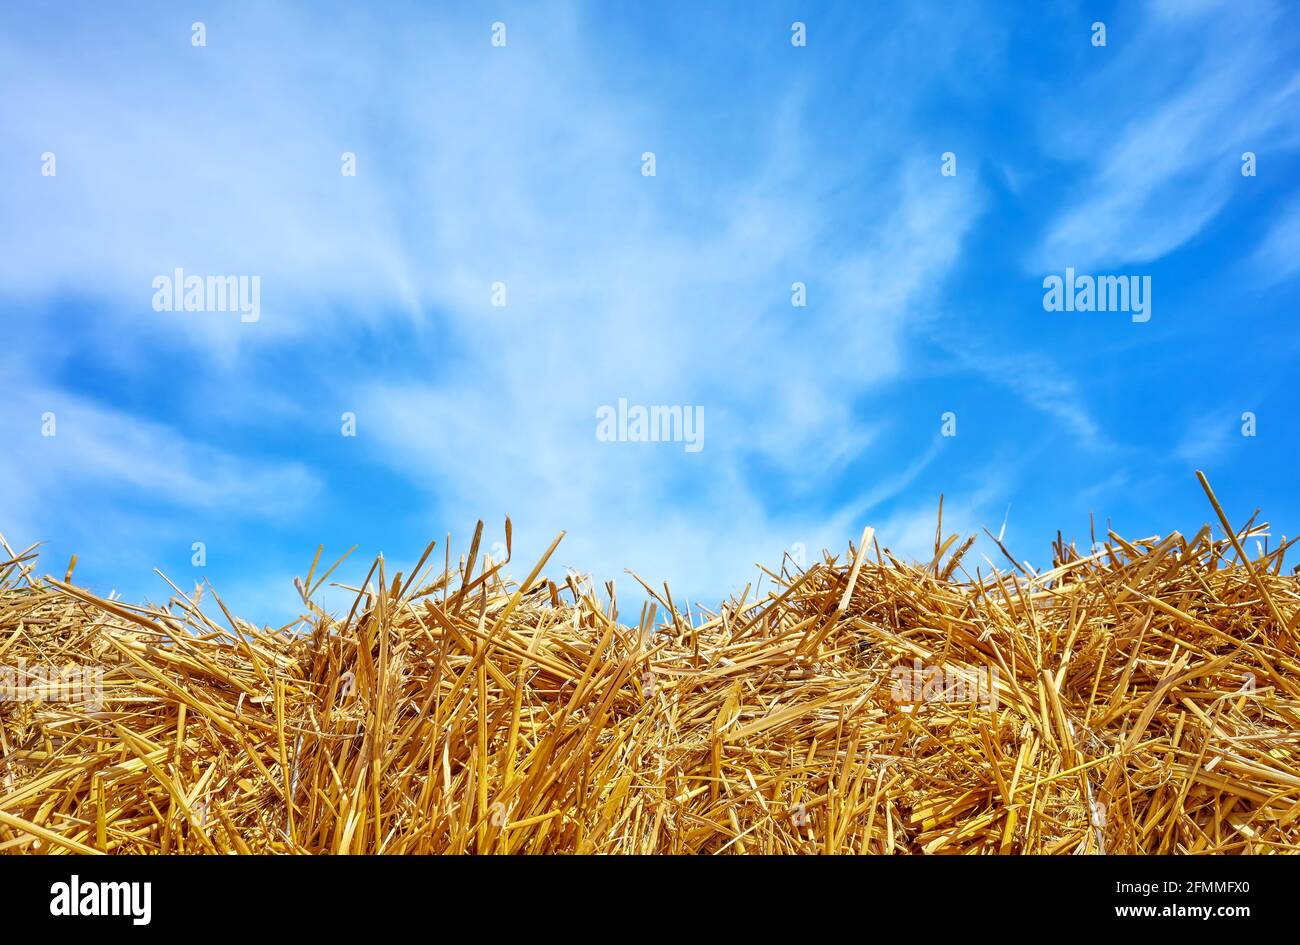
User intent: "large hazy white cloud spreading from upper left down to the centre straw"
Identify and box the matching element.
[0,0,980,610]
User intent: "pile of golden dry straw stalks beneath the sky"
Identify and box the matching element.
[0,475,1300,854]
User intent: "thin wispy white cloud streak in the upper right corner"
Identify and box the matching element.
[1031,3,1300,272]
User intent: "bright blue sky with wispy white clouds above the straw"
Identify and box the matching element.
[0,0,1300,623]
